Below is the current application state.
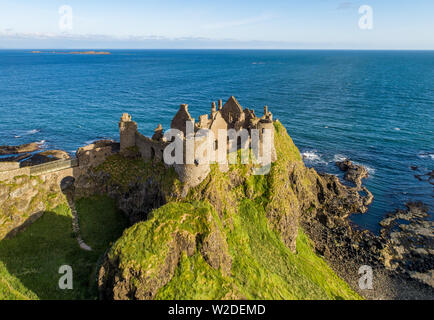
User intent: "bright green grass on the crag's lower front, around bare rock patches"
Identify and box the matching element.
[109,199,360,299]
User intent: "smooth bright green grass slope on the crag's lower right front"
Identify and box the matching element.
[228,200,359,299]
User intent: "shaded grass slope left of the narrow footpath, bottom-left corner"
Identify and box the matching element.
[0,206,98,299]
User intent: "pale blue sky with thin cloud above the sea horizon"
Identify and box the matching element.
[0,0,434,50]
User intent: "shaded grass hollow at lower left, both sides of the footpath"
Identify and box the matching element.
[0,197,126,300]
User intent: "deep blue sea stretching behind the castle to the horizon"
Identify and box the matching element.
[0,50,434,230]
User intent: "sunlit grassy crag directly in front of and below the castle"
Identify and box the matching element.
[100,122,360,299]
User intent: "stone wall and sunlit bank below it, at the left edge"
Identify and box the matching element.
[0,141,119,240]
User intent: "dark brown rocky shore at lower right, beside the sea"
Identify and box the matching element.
[301,159,434,299]
